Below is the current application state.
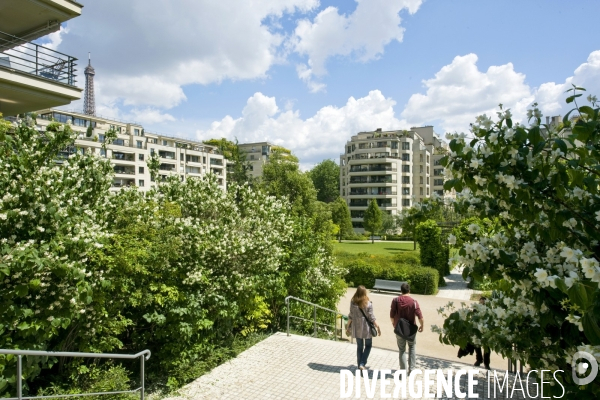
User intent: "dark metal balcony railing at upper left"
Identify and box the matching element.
[0,32,77,86]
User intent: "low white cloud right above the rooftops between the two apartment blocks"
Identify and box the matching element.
[197,90,406,167]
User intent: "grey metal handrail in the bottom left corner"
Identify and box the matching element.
[0,349,151,400]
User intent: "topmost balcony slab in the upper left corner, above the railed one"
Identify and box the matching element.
[0,0,83,40]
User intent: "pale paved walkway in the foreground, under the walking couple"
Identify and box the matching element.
[165,333,536,400]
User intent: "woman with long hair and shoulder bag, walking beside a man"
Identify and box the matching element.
[346,285,381,370]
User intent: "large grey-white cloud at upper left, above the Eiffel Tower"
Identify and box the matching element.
[55,0,319,108]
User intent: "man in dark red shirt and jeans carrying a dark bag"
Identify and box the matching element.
[390,283,424,376]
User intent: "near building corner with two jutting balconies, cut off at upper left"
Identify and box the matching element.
[0,0,83,117]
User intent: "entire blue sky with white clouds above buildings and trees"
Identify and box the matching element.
[40,0,600,169]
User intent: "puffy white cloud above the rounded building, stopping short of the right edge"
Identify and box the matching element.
[401,54,534,131]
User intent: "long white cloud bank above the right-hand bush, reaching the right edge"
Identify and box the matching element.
[401,50,600,132]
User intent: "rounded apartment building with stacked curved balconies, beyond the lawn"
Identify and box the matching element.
[340,126,452,231]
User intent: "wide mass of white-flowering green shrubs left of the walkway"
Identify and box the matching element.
[0,118,345,395]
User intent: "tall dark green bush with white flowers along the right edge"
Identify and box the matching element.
[437,87,600,398]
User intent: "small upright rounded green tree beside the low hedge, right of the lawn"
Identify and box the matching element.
[415,220,450,286]
